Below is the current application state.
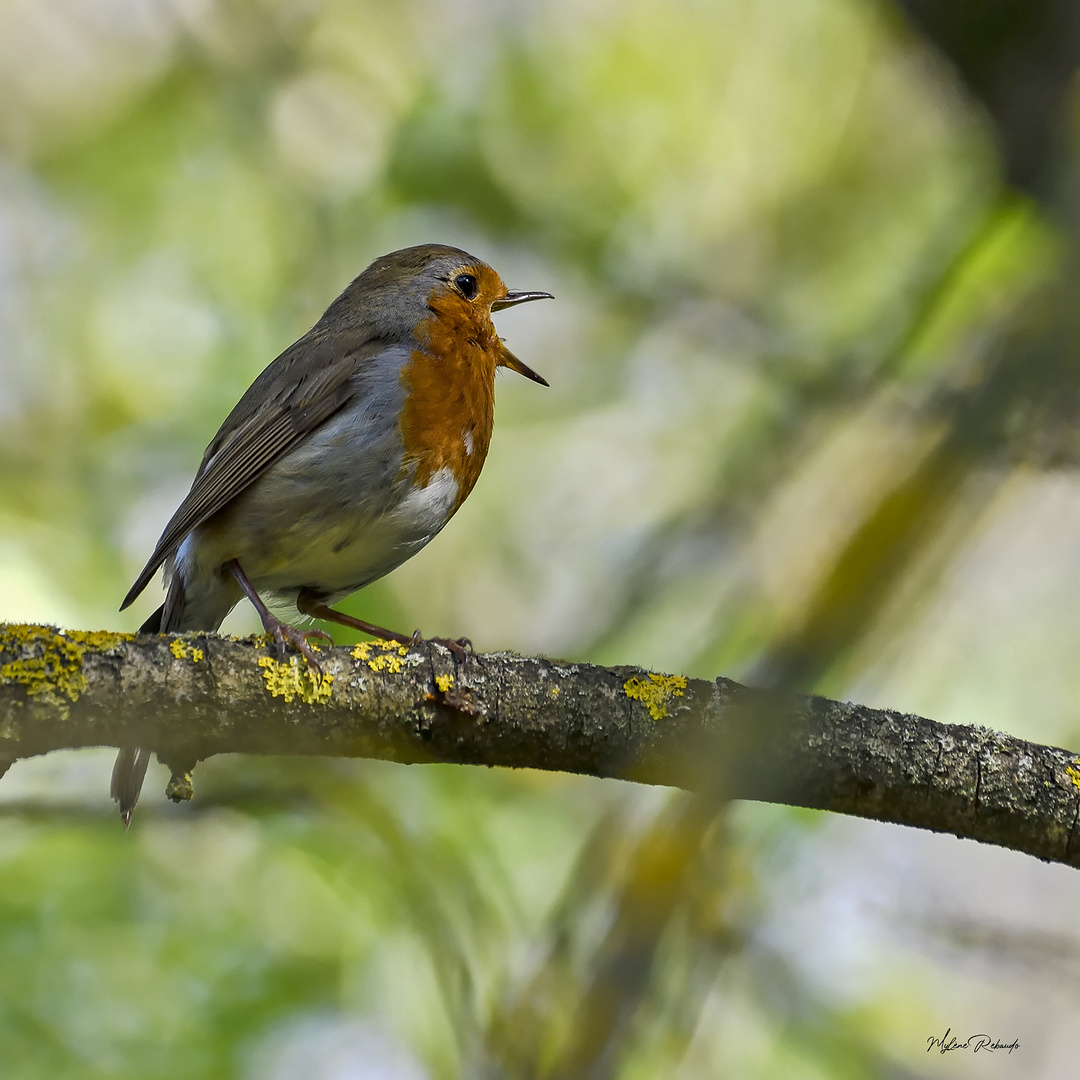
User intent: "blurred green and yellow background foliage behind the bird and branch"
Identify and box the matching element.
[0,0,1080,1080]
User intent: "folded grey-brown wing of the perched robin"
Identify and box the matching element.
[120,334,386,611]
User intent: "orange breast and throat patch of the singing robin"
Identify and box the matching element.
[401,282,500,514]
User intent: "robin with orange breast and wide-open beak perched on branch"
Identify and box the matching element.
[112,244,552,827]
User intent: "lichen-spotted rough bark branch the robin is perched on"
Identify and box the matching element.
[0,625,1080,866]
